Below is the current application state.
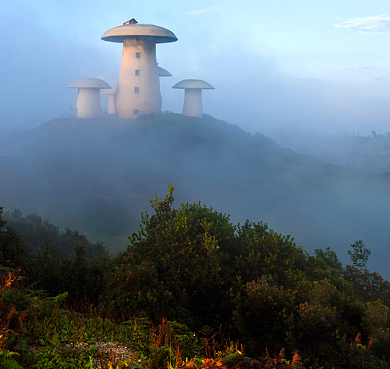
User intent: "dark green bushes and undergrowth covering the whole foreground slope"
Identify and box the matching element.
[0,187,390,369]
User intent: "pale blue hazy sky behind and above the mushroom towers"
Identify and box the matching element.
[0,0,390,135]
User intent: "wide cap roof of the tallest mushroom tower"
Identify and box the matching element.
[102,19,177,43]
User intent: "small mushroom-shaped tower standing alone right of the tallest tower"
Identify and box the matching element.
[172,79,214,118]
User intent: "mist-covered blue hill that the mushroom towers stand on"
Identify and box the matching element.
[0,114,390,274]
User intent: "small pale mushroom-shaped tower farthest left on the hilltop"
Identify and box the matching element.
[66,78,111,118]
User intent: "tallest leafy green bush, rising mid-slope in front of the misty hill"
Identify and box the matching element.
[127,186,235,324]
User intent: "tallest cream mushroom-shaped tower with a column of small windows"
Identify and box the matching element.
[102,19,177,119]
